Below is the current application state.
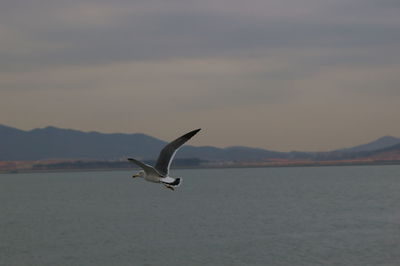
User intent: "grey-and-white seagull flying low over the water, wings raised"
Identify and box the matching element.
[128,128,200,190]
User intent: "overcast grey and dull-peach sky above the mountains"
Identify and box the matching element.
[0,0,400,151]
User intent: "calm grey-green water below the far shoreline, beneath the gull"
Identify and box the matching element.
[0,166,400,266]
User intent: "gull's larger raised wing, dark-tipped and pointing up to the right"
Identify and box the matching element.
[154,128,201,176]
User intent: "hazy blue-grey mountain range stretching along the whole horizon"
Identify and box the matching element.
[0,125,400,162]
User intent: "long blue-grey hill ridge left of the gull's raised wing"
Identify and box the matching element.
[0,126,165,160]
